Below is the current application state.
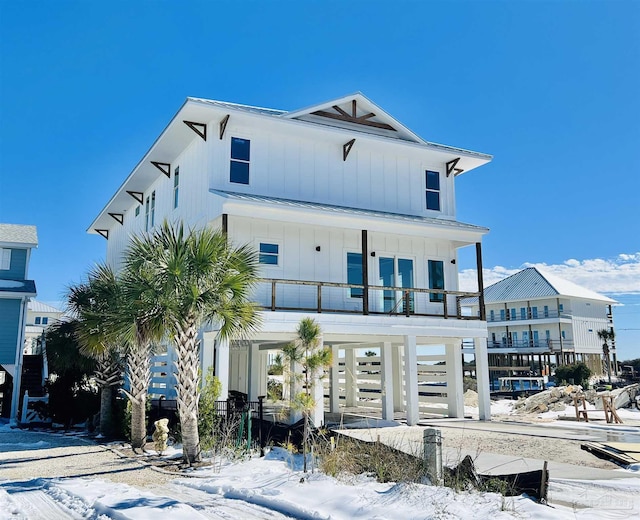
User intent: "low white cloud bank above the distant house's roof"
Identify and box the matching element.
[460,253,640,294]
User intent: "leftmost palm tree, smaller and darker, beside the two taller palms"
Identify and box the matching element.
[67,265,123,437]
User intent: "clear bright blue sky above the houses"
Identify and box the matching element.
[0,0,640,358]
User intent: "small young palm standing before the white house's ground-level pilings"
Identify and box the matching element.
[282,318,333,473]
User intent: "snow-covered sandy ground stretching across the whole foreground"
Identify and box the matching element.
[0,410,640,520]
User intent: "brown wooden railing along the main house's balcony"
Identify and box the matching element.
[258,278,483,320]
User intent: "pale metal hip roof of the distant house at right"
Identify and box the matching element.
[463,267,617,305]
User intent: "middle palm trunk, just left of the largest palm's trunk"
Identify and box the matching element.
[124,344,151,451]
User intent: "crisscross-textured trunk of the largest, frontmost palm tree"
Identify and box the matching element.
[175,320,201,464]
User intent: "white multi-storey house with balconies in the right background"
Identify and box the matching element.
[465,267,617,389]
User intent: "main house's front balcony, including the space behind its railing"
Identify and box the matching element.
[255,278,484,320]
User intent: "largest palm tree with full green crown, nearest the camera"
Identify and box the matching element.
[124,222,259,464]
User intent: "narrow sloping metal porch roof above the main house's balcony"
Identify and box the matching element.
[209,190,489,232]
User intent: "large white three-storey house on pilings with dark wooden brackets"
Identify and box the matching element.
[89,93,491,424]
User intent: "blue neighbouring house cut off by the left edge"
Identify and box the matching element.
[0,224,38,423]
